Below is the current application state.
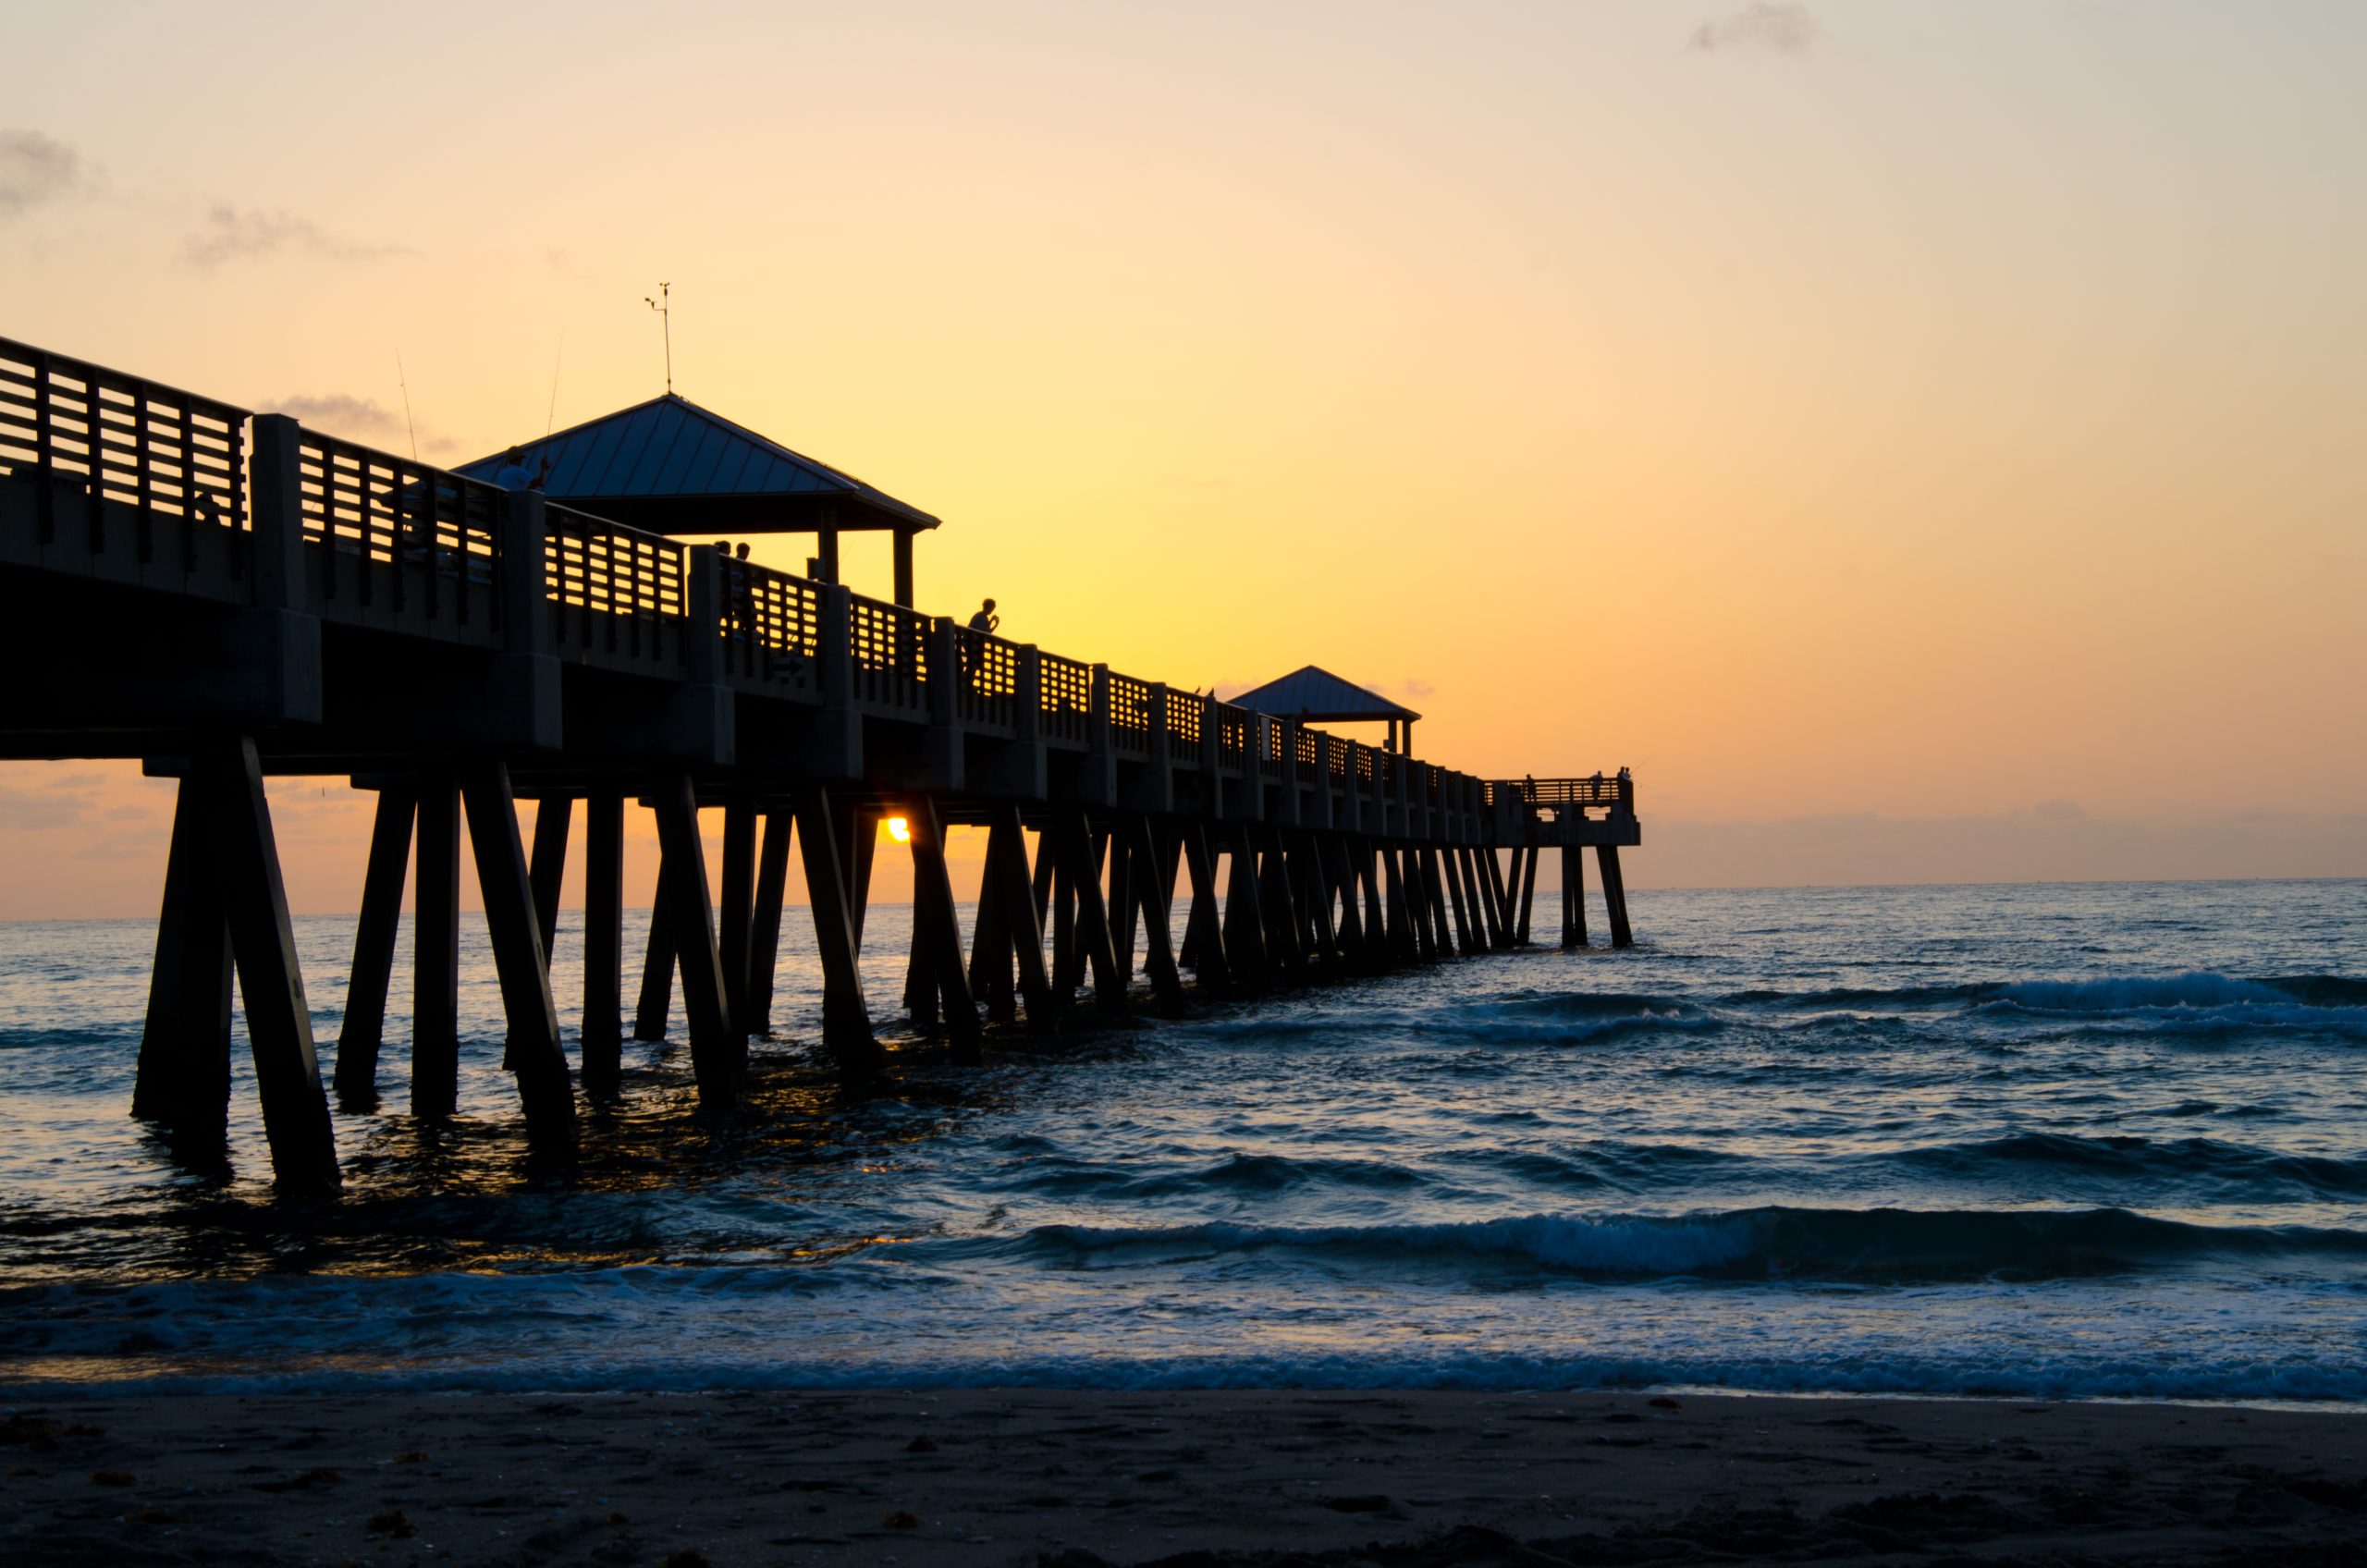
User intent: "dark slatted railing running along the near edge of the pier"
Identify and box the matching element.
[0,338,1633,822]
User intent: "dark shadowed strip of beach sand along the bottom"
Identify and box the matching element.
[0,1390,2367,1568]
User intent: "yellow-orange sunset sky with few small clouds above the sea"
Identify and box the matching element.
[0,0,2367,919]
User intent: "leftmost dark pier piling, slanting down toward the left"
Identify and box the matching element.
[132,772,235,1146]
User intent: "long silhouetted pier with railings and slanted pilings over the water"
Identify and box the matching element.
[0,338,1640,1194]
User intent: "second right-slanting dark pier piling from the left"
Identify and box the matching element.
[464,760,575,1156]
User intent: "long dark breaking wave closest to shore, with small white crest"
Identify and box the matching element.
[1006,1206,2367,1284]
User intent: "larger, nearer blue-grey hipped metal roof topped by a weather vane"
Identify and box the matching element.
[460,393,938,533]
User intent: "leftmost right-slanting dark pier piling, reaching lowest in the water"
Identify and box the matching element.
[196,737,338,1196]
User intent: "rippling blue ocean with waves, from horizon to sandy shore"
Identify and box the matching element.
[0,881,2367,1404]
